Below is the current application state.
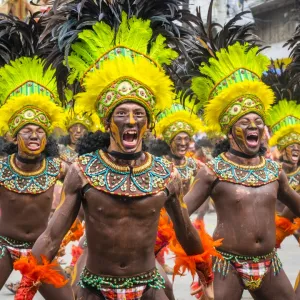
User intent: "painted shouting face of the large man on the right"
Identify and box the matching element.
[229,113,264,155]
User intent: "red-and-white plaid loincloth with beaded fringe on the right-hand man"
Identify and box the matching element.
[213,249,282,291]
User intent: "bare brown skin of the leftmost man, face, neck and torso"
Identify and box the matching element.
[0,125,72,299]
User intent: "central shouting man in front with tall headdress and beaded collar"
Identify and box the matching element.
[16,13,210,300]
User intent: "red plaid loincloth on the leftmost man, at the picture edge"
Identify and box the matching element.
[0,236,34,262]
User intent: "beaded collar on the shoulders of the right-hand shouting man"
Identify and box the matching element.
[206,153,281,187]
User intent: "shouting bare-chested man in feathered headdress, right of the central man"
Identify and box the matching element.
[185,43,300,300]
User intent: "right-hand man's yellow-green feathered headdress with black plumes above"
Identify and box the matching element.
[180,1,274,134]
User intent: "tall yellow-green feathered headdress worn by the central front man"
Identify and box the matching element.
[72,13,177,124]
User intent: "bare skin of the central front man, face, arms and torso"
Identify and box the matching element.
[33,103,203,300]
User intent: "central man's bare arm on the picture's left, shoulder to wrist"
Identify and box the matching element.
[32,163,83,261]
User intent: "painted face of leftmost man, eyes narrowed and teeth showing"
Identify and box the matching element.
[17,125,47,156]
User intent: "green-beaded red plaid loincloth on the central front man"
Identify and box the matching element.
[79,268,165,300]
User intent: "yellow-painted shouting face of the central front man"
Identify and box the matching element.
[109,103,148,153]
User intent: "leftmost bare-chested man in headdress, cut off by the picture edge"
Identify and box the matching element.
[0,57,70,299]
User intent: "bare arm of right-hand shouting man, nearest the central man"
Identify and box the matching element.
[184,165,217,215]
